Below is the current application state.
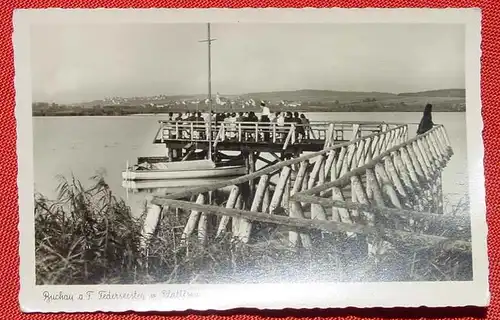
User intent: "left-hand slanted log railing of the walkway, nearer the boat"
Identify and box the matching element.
[139,125,408,245]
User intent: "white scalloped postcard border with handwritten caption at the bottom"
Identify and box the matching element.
[13,8,490,312]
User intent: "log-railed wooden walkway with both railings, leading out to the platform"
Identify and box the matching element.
[136,124,471,254]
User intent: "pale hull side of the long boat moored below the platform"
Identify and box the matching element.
[122,166,246,180]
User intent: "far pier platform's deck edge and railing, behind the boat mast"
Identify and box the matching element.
[154,121,397,155]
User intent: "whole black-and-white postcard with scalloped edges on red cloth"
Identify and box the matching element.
[14,9,489,312]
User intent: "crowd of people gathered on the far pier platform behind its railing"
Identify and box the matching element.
[164,103,311,142]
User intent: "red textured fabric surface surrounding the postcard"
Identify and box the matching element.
[0,0,500,320]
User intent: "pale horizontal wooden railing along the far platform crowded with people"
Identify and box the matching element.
[155,121,406,146]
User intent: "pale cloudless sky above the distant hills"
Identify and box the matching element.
[31,23,465,103]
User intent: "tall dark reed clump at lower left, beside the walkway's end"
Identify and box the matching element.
[35,176,141,284]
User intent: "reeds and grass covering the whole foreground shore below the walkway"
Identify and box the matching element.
[34,176,472,285]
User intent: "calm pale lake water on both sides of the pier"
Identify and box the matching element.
[33,112,468,215]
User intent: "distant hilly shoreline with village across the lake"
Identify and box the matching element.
[32,89,465,117]
